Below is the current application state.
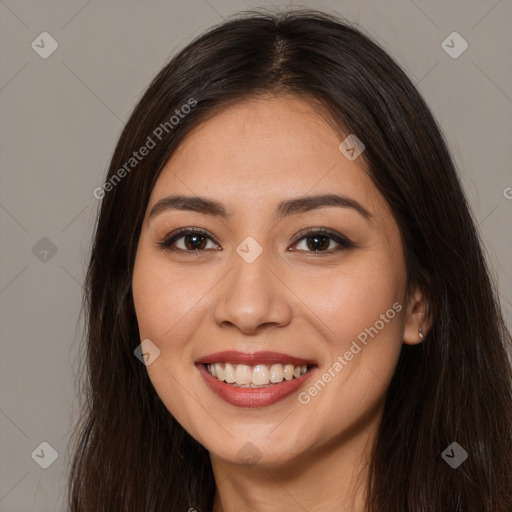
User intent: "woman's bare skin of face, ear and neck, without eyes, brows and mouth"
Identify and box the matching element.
[132,96,431,512]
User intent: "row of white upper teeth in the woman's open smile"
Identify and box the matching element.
[206,363,308,388]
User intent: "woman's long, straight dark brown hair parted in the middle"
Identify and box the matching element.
[69,9,512,512]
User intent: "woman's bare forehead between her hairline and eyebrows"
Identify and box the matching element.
[148,96,386,222]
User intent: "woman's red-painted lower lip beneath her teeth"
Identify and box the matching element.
[197,364,316,407]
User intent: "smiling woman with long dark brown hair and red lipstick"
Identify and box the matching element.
[69,10,512,512]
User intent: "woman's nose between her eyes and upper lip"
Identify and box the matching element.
[214,251,293,334]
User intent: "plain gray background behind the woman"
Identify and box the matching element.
[0,0,512,512]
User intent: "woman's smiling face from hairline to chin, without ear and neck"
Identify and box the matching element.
[132,97,420,466]
